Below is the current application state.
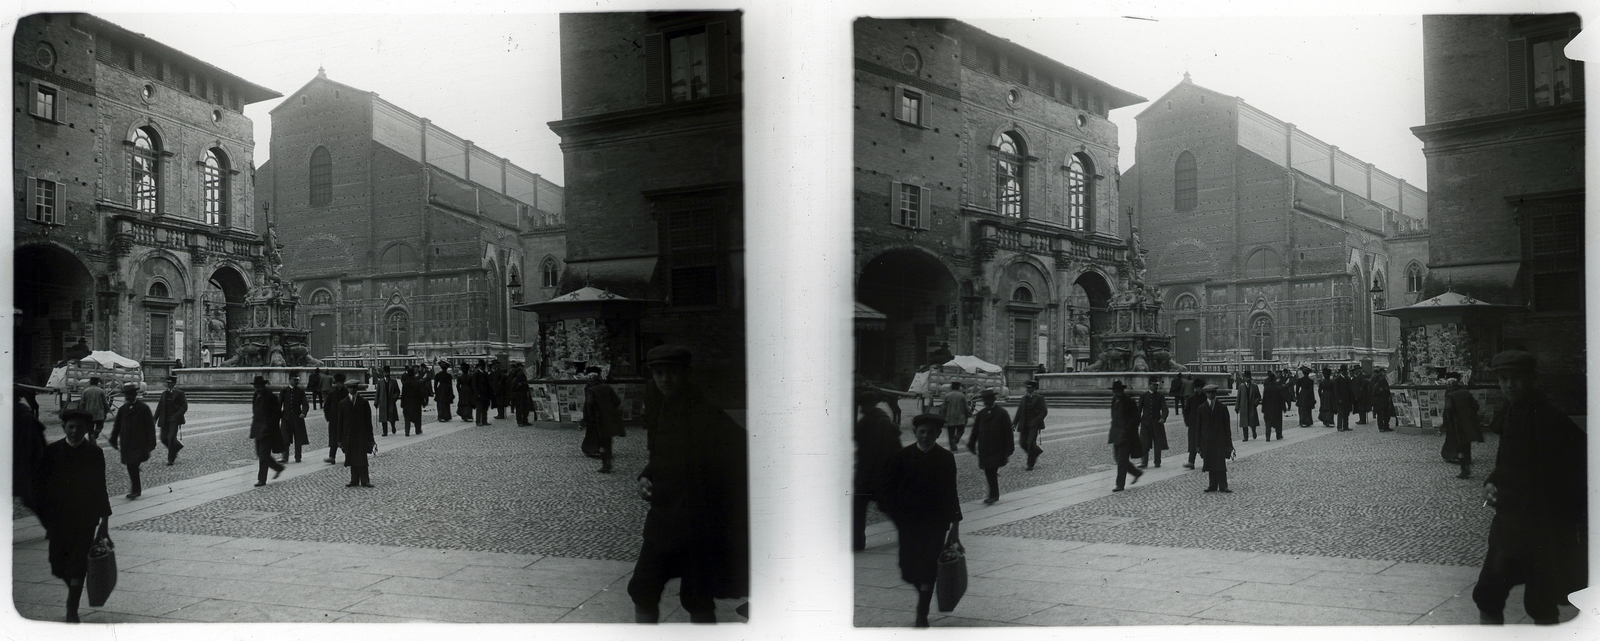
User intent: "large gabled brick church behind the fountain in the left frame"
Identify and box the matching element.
[259,70,565,361]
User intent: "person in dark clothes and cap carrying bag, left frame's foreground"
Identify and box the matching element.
[34,408,110,623]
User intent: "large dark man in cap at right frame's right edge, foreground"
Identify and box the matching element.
[1472,350,1589,625]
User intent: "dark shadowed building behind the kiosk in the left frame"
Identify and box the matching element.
[544,11,746,408]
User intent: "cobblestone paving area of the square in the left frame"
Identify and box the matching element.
[116,419,648,561]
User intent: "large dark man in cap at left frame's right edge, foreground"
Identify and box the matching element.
[627,345,750,623]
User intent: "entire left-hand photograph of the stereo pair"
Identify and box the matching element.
[6,6,750,623]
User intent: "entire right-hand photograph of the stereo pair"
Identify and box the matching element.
[843,12,1589,627]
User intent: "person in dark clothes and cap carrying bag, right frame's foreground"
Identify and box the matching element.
[880,412,960,628]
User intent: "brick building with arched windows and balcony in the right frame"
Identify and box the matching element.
[854,19,1144,387]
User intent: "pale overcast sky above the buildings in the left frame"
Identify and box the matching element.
[96,11,565,185]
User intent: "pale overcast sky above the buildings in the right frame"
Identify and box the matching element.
[966,16,1427,189]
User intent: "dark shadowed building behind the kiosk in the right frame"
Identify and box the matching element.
[1411,13,1587,414]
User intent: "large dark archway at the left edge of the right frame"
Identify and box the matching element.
[856,249,962,388]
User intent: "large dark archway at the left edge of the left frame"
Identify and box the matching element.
[13,245,93,385]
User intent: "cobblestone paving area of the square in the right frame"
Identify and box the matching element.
[962,425,1499,566]
